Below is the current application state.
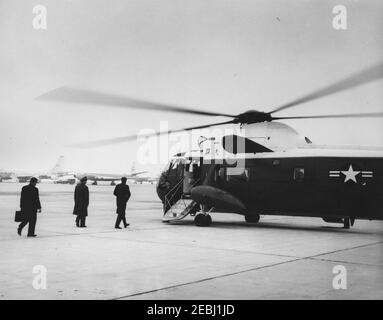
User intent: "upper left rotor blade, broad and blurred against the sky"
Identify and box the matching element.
[36,87,235,118]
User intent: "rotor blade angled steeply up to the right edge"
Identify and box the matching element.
[269,63,383,114]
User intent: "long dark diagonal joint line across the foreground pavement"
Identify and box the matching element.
[111,241,383,300]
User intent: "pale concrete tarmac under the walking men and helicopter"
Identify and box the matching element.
[0,183,383,300]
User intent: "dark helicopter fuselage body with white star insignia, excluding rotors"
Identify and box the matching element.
[158,149,383,224]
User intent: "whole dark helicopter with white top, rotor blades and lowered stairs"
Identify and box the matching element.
[37,63,383,229]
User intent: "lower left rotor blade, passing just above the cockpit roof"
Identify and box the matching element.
[68,120,235,148]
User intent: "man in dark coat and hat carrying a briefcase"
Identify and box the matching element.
[17,177,41,237]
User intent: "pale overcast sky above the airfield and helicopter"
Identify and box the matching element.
[0,0,383,172]
